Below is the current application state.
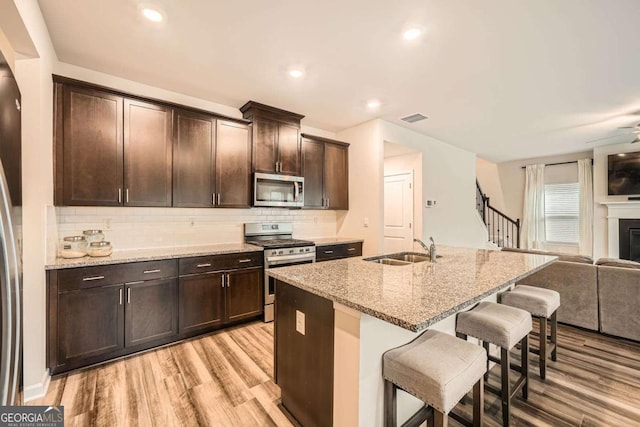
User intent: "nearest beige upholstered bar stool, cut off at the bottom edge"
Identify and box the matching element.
[382,330,487,427]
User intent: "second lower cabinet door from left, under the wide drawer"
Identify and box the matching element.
[125,279,178,347]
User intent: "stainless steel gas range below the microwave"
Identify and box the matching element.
[244,222,316,322]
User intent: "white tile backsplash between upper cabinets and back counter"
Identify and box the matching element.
[53,207,336,256]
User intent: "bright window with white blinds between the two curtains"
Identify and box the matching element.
[544,182,580,244]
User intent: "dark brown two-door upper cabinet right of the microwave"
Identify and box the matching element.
[302,134,349,210]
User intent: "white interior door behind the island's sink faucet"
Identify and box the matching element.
[384,172,413,254]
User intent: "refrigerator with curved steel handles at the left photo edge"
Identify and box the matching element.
[0,48,22,405]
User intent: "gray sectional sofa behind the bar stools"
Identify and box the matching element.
[503,248,640,341]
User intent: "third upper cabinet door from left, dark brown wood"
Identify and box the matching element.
[173,110,215,207]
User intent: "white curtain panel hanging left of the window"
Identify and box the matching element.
[521,164,545,249]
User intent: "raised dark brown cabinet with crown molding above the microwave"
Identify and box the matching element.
[240,101,304,176]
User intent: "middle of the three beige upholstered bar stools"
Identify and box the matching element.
[456,302,531,427]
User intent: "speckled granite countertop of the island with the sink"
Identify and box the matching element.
[268,245,557,332]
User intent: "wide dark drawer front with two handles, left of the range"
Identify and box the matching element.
[58,260,177,292]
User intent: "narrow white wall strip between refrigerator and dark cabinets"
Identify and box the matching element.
[9,0,57,400]
